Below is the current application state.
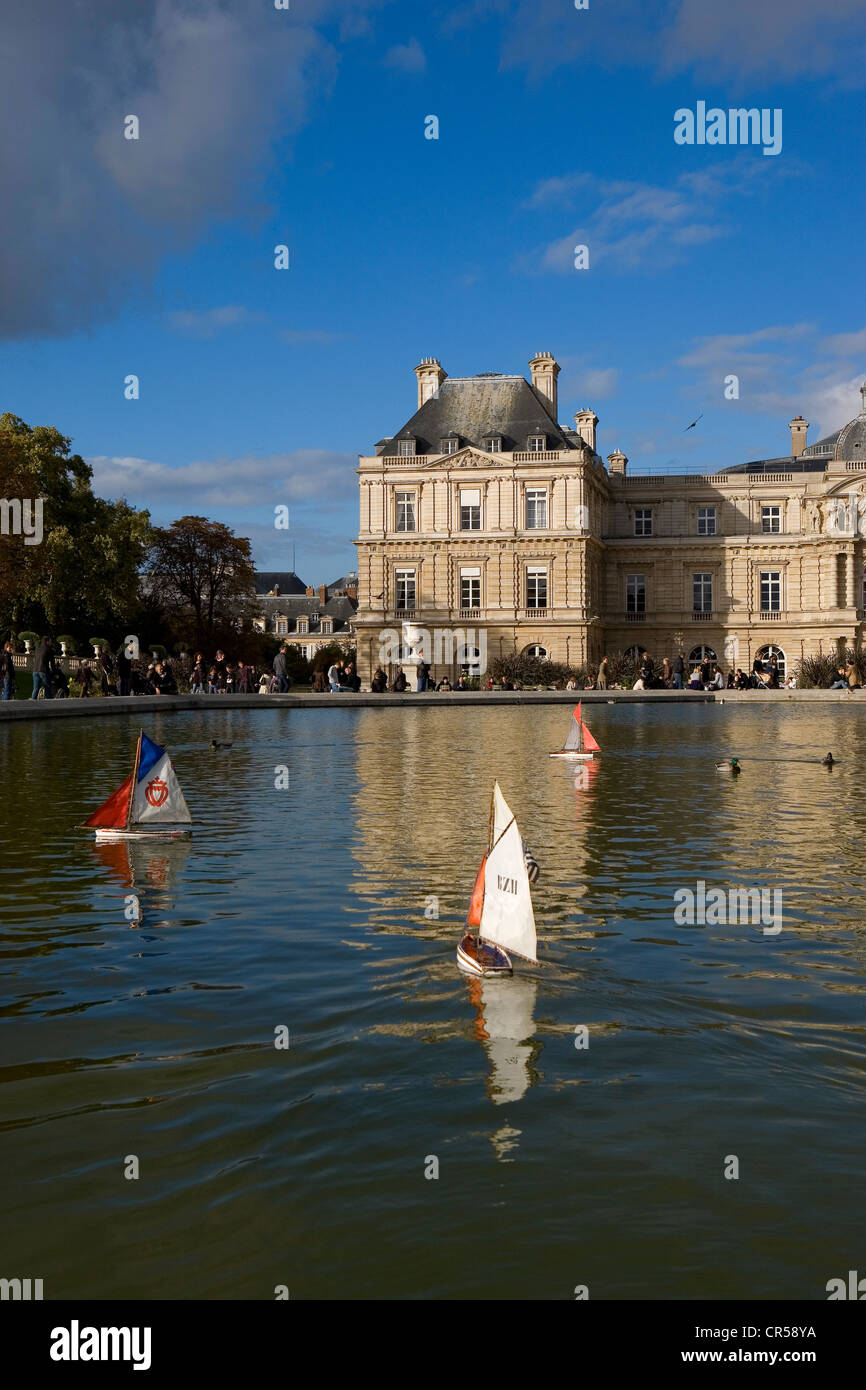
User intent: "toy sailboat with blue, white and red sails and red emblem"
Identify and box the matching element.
[85,731,192,840]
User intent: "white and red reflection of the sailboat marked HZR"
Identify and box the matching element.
[468,974,538,1105]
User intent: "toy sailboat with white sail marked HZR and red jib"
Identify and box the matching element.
[457,783,538,976]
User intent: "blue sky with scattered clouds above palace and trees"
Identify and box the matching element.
[0,0,866,584]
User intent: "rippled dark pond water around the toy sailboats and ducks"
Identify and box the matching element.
[0,703,866,1298]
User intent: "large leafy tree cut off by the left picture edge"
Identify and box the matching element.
[0,413,150,634]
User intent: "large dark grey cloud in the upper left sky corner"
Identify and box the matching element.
[0,0,378,338]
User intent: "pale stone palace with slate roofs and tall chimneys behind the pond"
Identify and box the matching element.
[356,353,866,681]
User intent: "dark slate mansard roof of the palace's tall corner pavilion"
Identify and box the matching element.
[377,373,582,455]
